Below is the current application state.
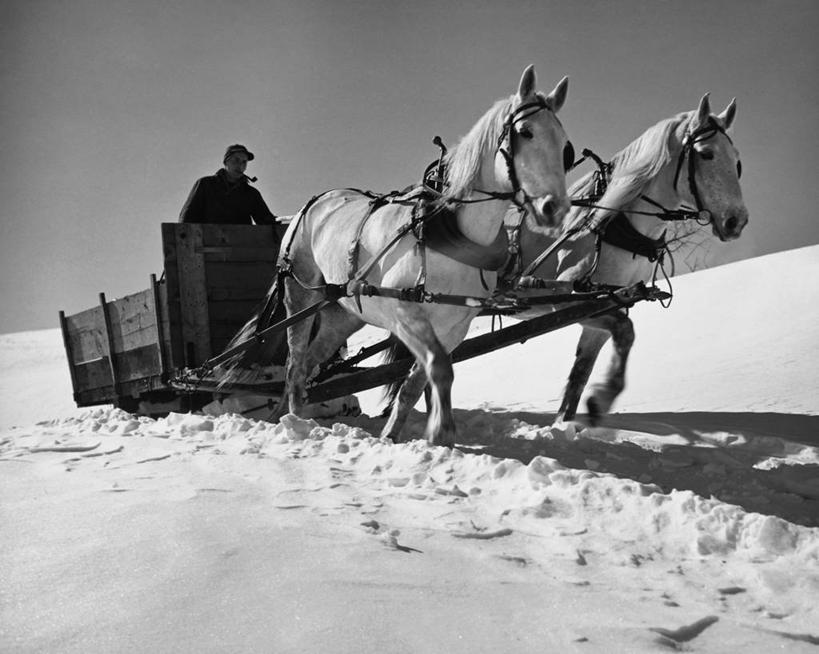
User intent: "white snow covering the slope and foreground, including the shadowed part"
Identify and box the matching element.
[0,246,819,652]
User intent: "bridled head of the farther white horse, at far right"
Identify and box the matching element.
[674,93,748,241]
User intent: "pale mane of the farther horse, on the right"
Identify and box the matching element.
[564,111,696,228]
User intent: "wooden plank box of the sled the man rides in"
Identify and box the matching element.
[60,223,285,406]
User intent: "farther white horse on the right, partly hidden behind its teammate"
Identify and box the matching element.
[507,94,748,423]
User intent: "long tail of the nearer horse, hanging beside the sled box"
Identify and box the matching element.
[213,271,287,390]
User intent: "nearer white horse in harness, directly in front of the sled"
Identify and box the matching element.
[221,66,570,445]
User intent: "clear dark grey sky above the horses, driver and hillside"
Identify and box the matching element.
[0,0,819,332]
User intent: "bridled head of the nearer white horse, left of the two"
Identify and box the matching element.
[495,66,574,226]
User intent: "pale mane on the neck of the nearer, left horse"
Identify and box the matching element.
[444,93,545,201]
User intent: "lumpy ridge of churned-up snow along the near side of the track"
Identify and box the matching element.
[20,409,819,560]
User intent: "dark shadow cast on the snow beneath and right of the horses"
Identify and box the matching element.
[350,409,819,527]
